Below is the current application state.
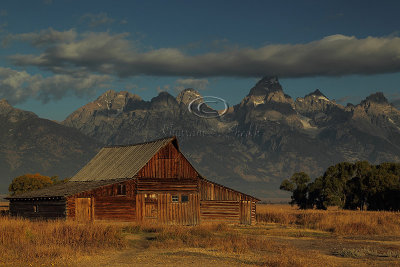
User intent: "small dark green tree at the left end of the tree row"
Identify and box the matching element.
[280,172,310,209]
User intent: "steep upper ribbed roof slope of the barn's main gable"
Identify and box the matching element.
[70,137,176,182]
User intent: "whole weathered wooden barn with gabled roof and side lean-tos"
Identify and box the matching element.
[8,137,259,225]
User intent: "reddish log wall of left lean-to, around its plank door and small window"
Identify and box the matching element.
[67,179,136,221]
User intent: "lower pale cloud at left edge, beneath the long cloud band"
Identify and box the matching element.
[0,67,111,104]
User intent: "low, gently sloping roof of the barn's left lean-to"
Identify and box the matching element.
[7,178,130,199]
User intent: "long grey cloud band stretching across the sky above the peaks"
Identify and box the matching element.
[10,32,400,78]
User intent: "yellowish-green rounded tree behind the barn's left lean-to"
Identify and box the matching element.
[8,173,56,195]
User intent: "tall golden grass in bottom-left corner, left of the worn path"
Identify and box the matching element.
[0,217,126,266]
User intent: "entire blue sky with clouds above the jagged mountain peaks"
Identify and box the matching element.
[0,0,400,120]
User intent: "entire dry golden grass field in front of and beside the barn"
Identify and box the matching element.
[0,205,400,266]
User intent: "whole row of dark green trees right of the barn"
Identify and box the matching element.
[280,161,400,211]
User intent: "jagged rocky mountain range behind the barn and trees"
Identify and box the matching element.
[0,77,400,199]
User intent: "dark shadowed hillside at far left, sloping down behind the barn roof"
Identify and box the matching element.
[0,99,100,193]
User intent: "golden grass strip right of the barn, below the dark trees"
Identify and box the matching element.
[257,204,400,235]
